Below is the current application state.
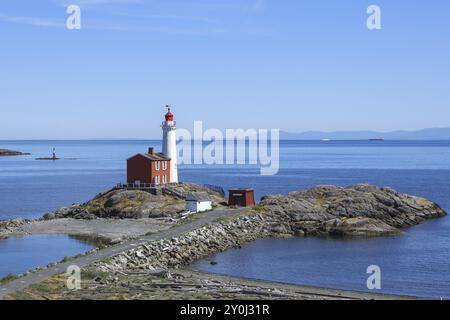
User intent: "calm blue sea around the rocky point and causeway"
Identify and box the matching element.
[0,141,450,298]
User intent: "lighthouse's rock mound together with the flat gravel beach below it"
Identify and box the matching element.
[0,183,226,243]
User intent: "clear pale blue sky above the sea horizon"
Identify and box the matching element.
[0,0,450,139]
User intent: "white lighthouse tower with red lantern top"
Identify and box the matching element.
[161,106,178,183]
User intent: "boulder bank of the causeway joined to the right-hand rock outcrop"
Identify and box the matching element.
[96,185,446,271]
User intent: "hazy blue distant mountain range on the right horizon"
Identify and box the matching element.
[280,128,450,140]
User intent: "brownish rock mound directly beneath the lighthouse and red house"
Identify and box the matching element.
[44,183,225,220]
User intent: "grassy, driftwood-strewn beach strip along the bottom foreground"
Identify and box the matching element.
[0,266,418,300]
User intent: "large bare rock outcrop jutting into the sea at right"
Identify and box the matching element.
[259,184,446,236]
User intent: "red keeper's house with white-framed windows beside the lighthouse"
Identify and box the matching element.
[127,148,170,186]
